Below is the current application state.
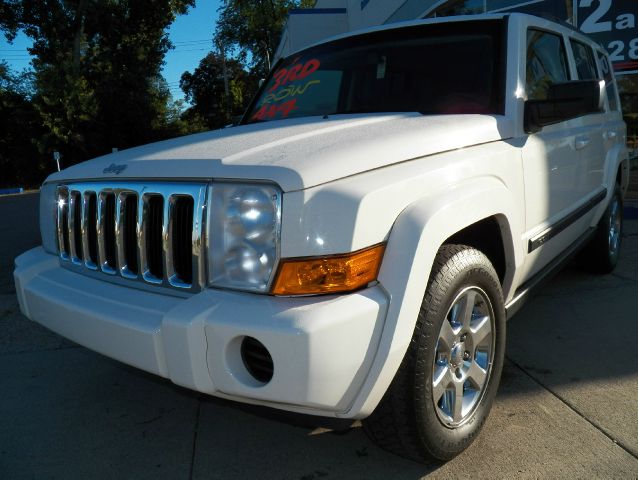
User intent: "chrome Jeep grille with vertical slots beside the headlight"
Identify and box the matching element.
[57,182,207,291]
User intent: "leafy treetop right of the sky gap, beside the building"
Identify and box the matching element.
[215,0,315,78]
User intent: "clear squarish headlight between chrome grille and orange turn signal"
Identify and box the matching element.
[208,183,281,292]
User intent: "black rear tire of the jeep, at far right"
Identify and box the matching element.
[579,185,623,274]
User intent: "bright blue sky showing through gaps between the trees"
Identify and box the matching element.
[0,0,221,99]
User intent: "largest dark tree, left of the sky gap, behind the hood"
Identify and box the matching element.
[20,0,194,165]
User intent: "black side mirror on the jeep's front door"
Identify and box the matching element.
[524,80,604,133]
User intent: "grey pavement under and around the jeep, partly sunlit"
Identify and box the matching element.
[0,194,638,480]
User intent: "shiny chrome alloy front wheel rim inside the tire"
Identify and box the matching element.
[432,287,495,428]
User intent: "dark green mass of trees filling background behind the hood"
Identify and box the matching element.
[0,0,314,186]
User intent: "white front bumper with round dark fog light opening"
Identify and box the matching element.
[14,247,389,418]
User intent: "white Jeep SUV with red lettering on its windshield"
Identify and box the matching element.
[15,14,629,461]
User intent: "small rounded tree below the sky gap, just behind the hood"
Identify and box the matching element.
[179,52,258,129]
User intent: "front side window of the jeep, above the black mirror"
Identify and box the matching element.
[526,29,569,100]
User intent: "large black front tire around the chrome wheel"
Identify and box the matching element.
[363,245,506,463]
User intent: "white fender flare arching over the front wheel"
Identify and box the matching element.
[343,177,524,418]
